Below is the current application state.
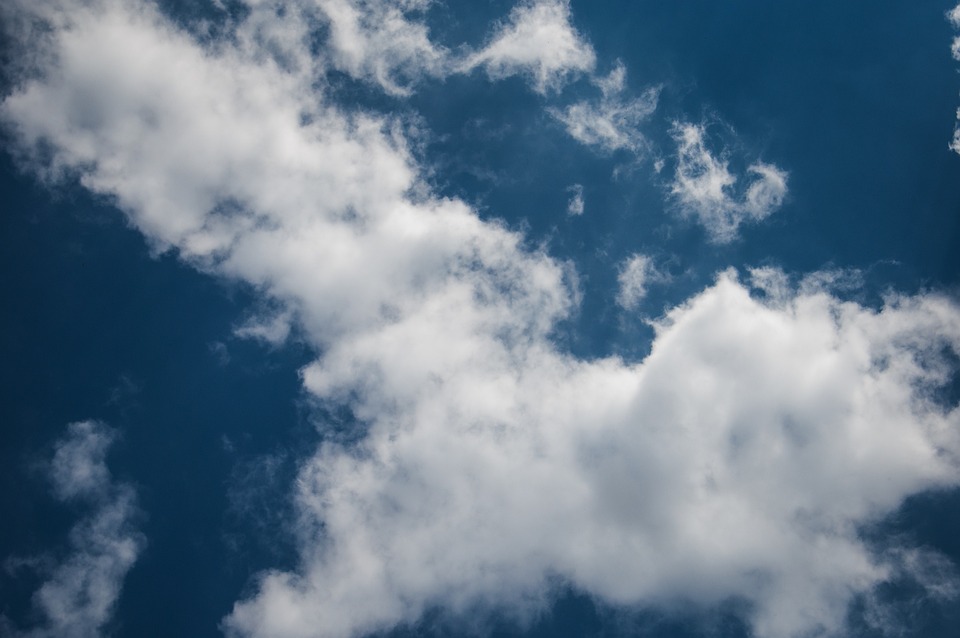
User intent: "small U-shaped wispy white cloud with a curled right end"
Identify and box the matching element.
[670,123,787,243]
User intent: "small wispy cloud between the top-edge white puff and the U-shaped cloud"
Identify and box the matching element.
[549,64,660,153]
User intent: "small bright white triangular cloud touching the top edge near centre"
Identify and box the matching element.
[464,0,596,93]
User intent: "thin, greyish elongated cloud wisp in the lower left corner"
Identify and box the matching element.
[5,421,144,638]
